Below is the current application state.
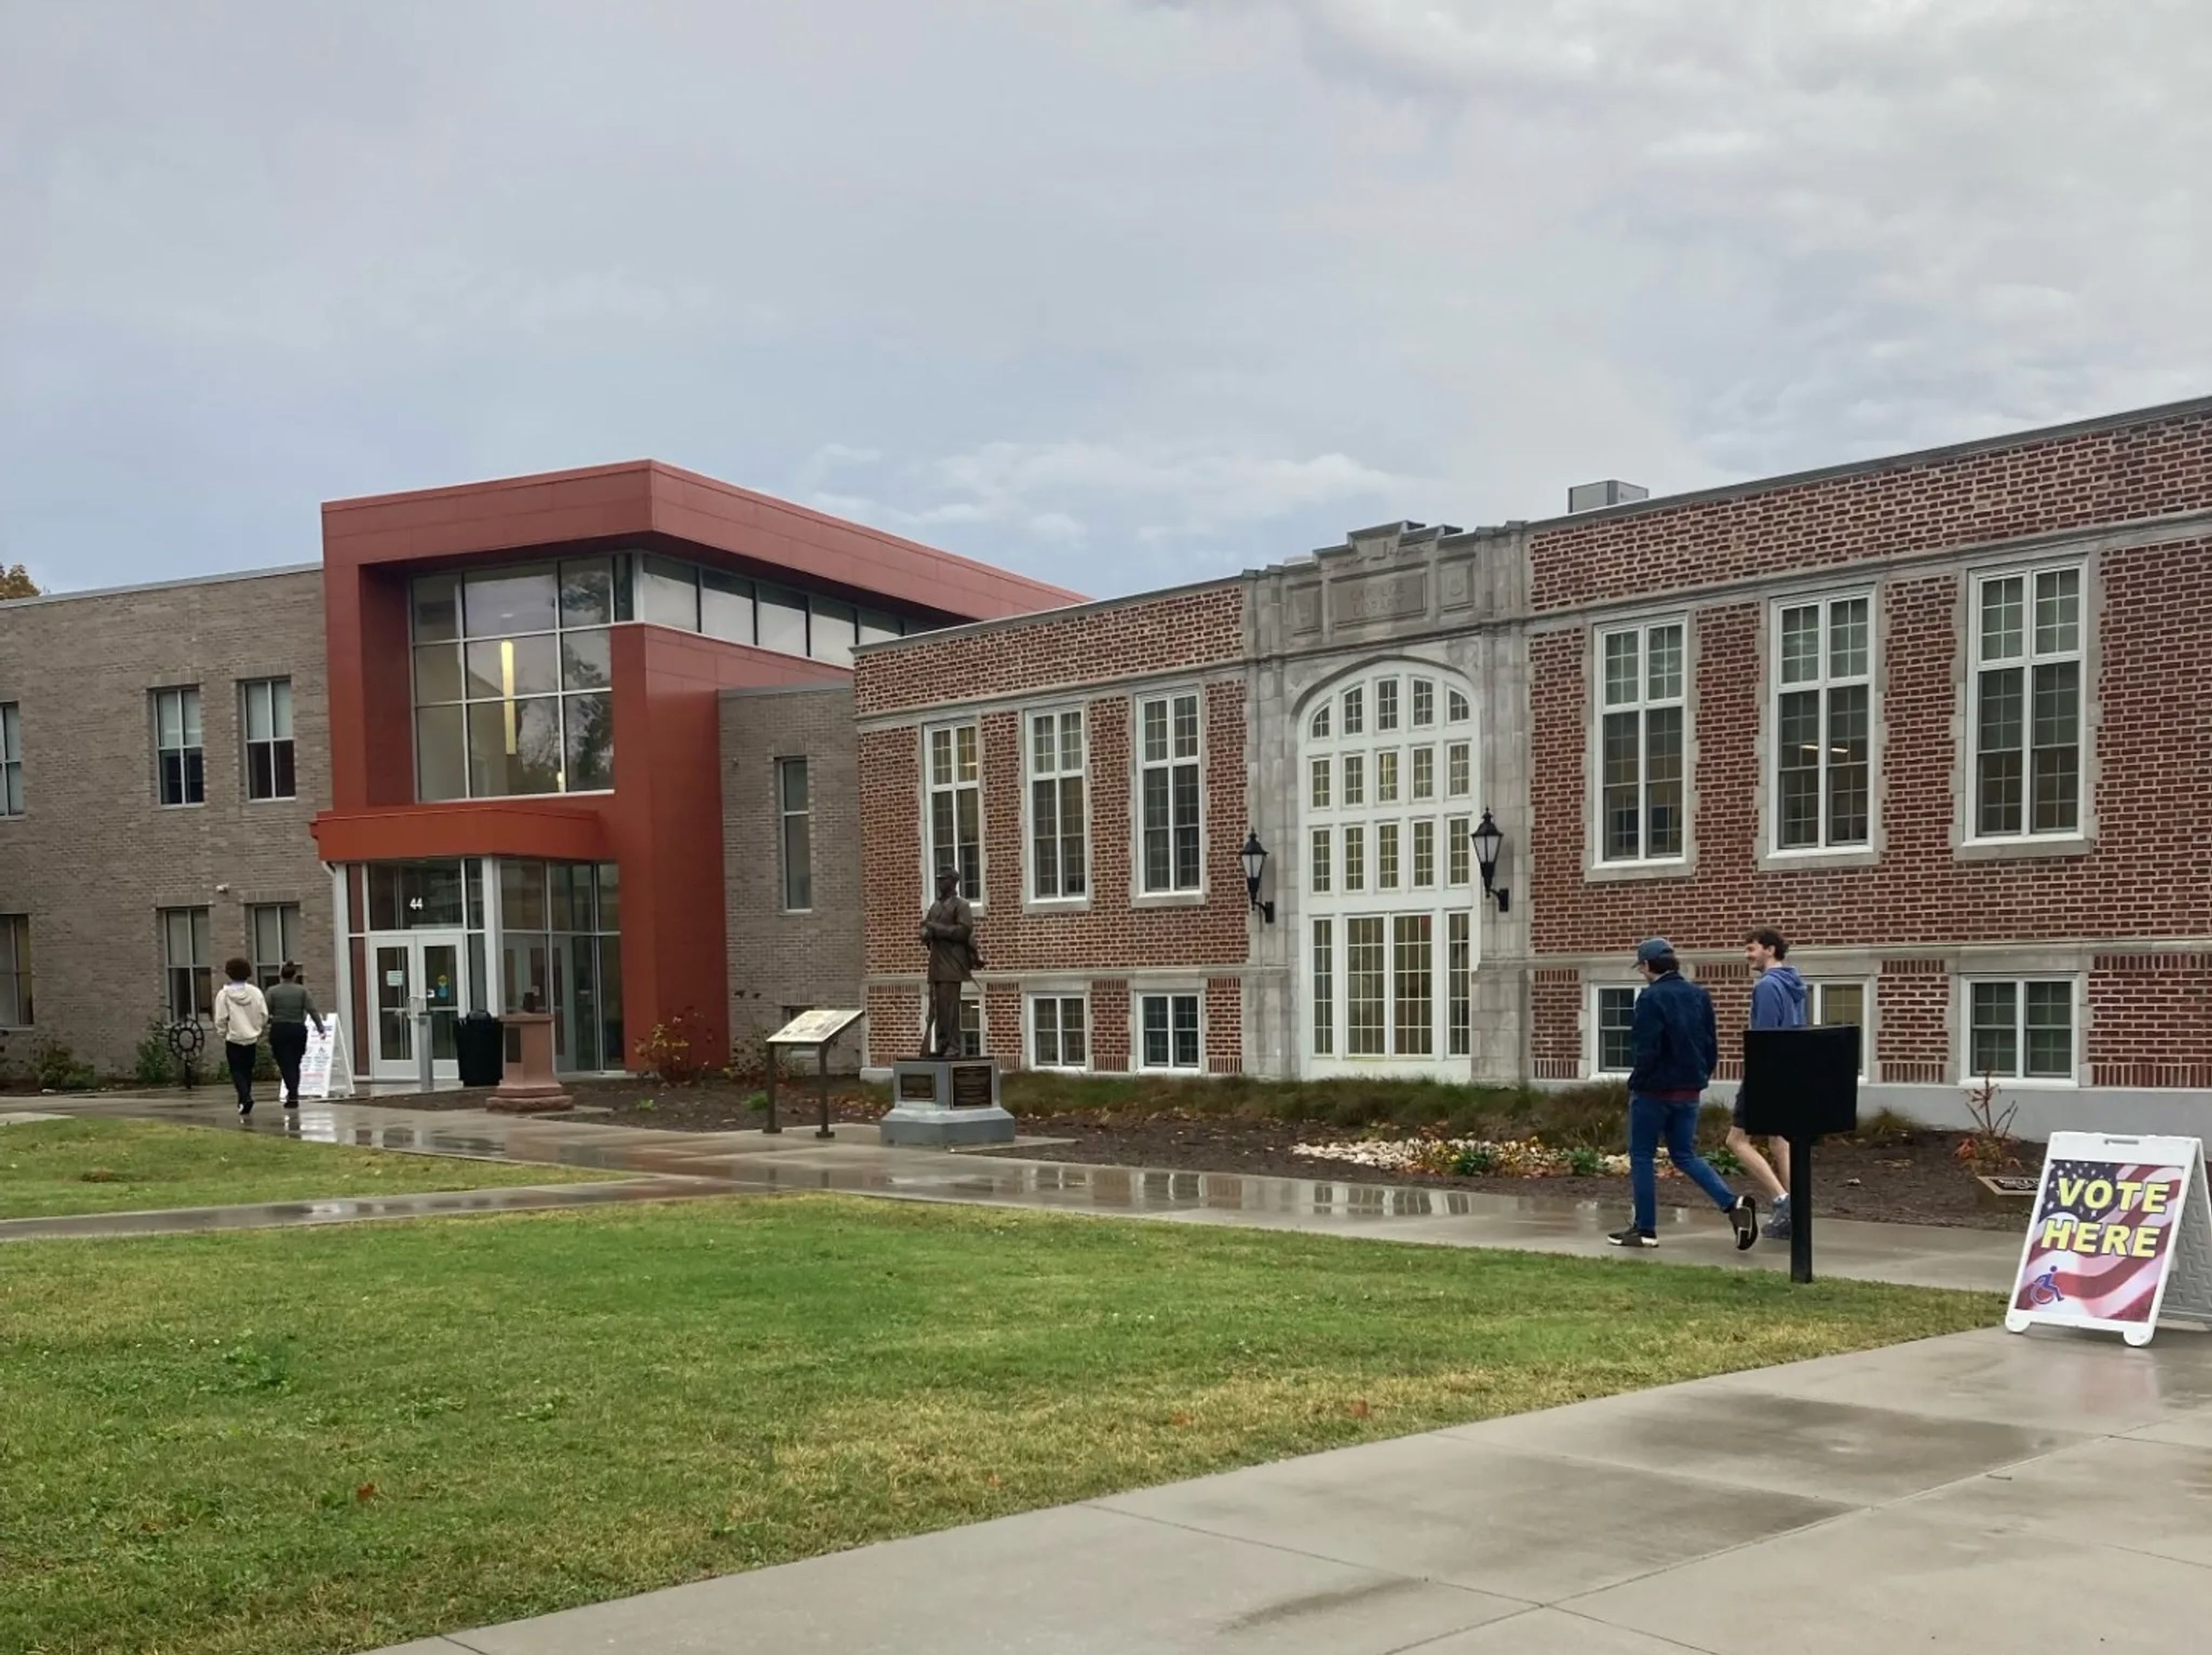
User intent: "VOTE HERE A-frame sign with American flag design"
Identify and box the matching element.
[2004,1133,2212,1345]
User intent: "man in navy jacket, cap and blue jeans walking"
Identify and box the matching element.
[1606,936,1759,1250]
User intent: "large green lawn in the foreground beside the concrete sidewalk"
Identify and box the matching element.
[0,1197,1999,1655]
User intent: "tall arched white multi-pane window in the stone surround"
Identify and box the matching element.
[1298,660,1480,1075]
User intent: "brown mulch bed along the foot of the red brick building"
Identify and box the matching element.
[354,1078,2035,1230]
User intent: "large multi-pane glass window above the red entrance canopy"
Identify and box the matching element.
[414,558,615,799]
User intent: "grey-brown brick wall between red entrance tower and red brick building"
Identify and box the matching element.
[721,684,865,1069]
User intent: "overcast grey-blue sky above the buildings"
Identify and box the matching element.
[0,0,2212,595]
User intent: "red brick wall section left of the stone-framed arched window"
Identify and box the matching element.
[856,586,1250,1073]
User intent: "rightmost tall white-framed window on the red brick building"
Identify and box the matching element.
[1971,564,2084,841]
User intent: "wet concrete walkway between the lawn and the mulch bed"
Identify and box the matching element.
[0,1093,2020,1292]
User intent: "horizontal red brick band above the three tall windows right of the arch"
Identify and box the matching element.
[1528,410,2212,613]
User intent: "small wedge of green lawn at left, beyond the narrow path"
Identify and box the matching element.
[0,1120,606,1219]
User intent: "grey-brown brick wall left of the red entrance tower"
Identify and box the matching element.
[0,571,332,1071]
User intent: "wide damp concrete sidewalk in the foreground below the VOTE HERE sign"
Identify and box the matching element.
[385,1330,2212,1655]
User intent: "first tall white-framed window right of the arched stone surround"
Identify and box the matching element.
[1597,619,1688,863]
